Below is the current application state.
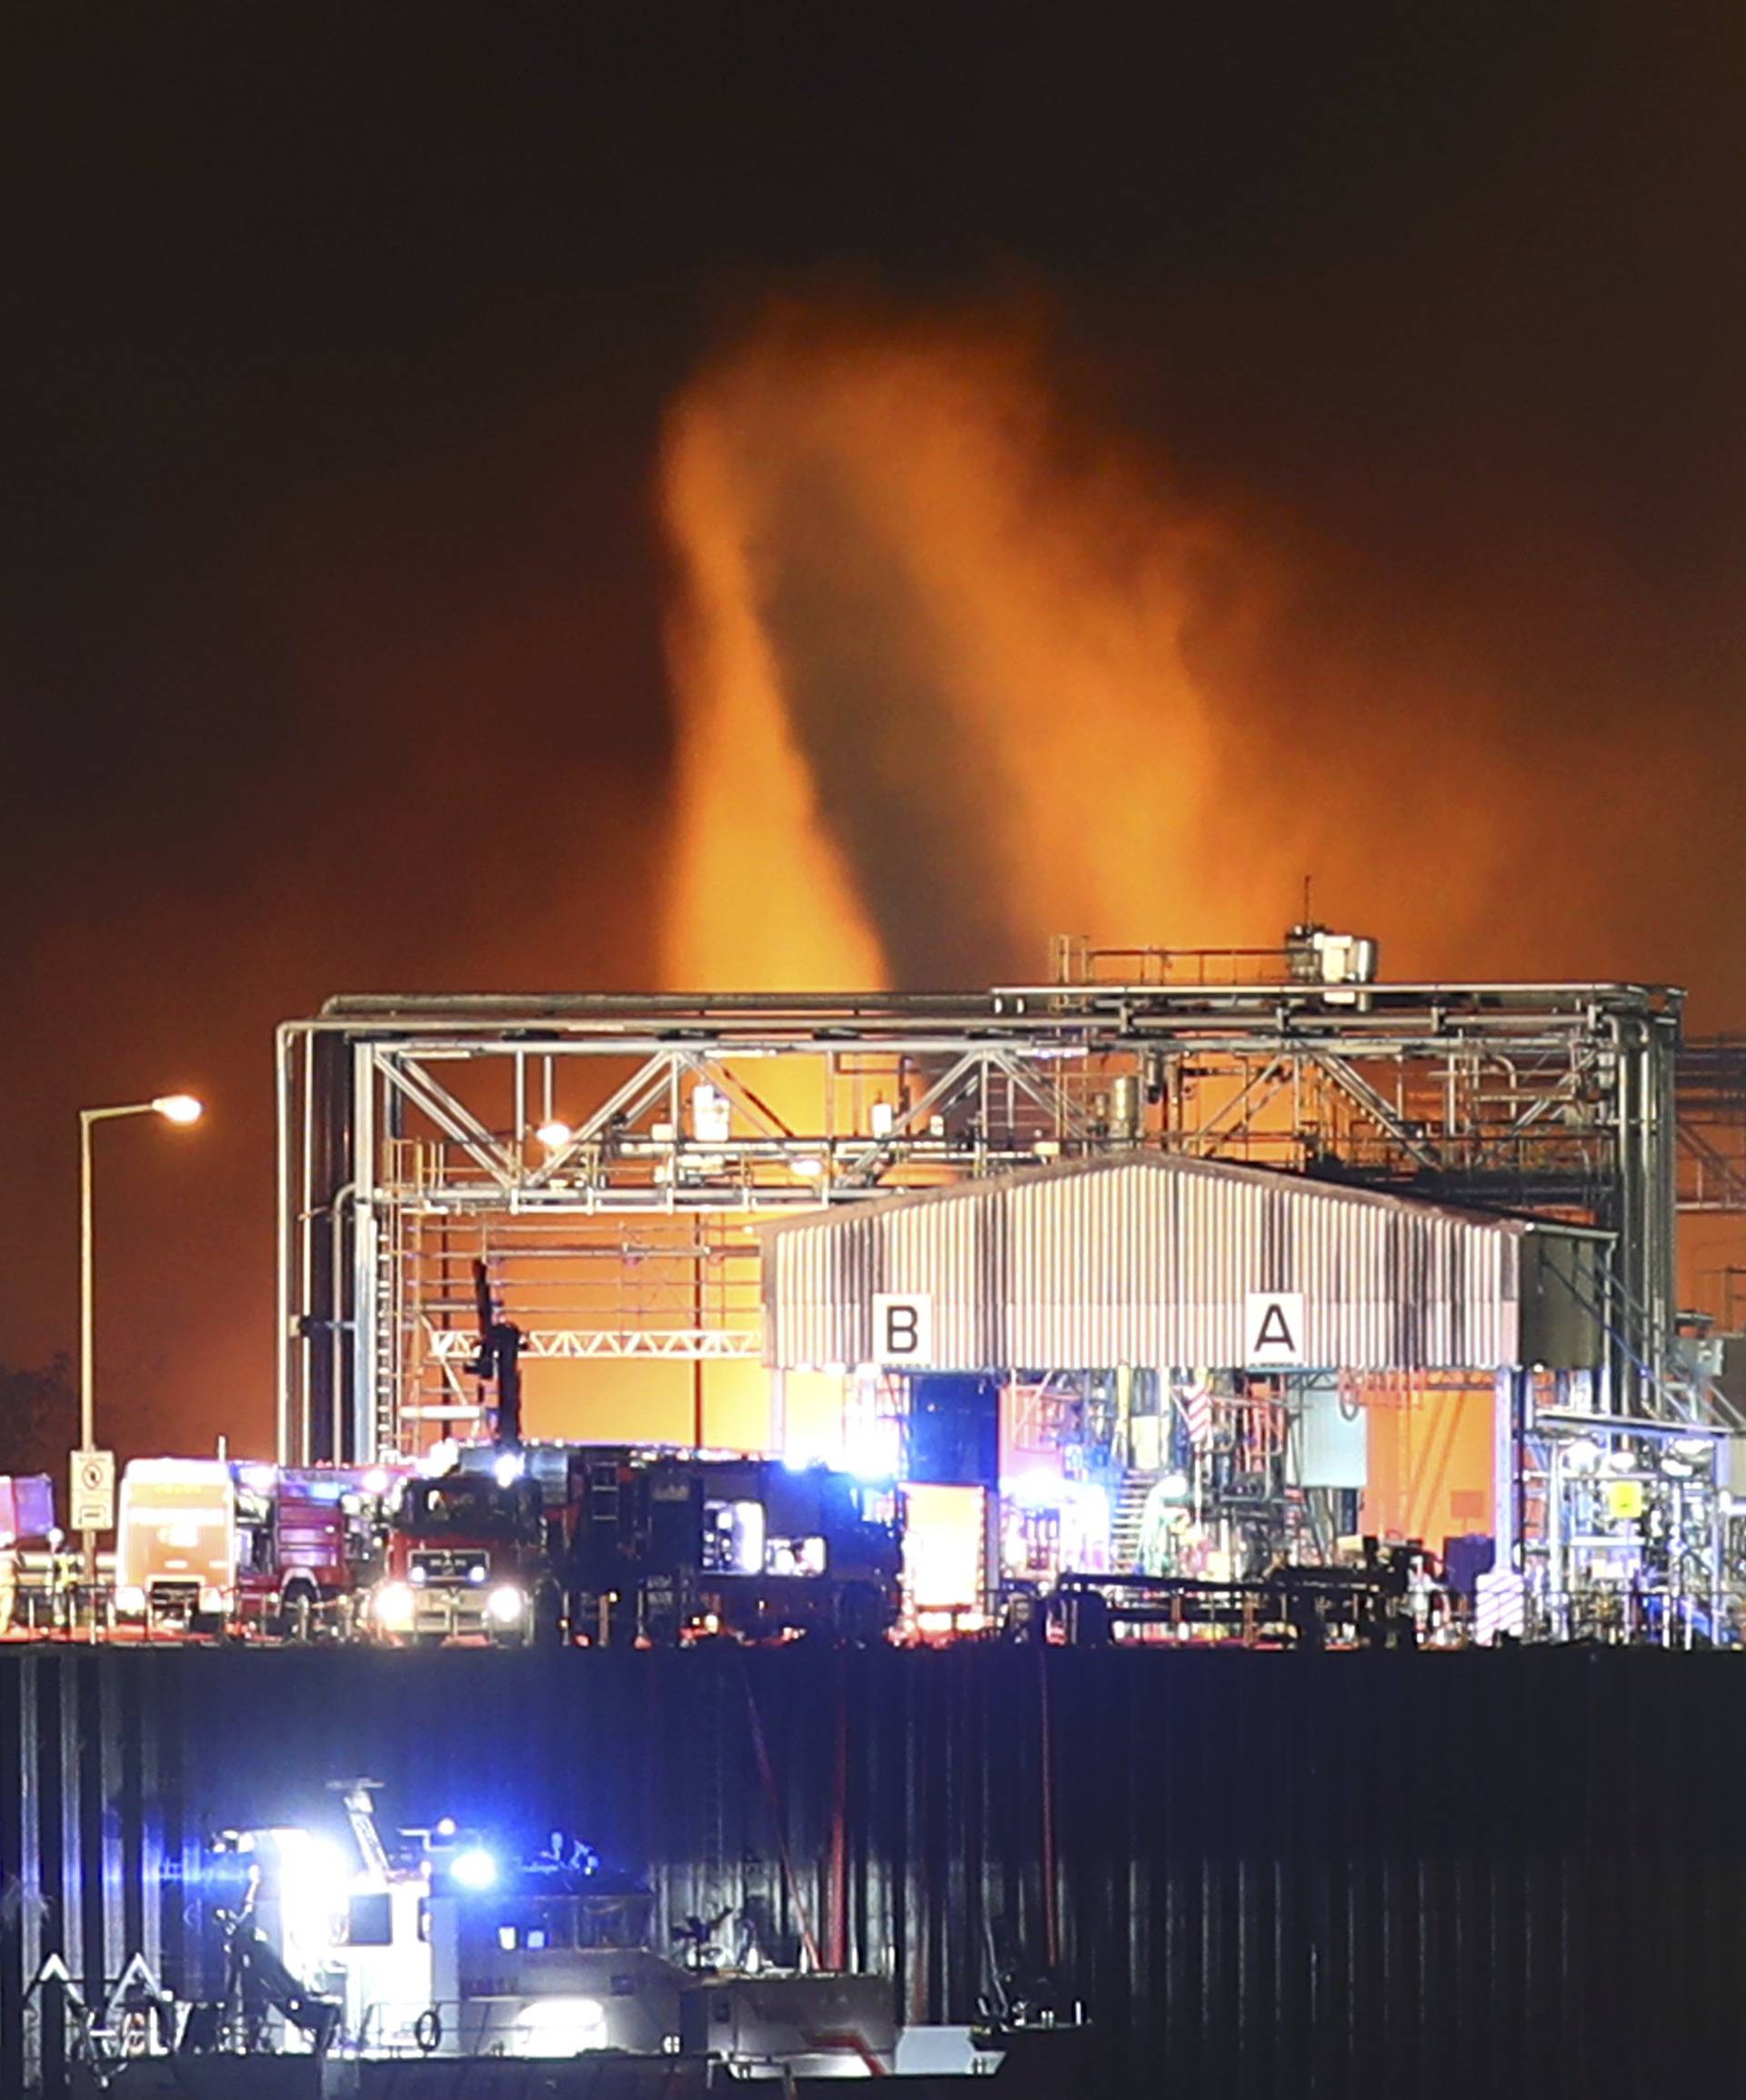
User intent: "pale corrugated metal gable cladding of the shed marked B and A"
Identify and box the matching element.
[764,1153,1610,1372]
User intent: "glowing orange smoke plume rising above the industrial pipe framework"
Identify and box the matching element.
[663,305,1526,990]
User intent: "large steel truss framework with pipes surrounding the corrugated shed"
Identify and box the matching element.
[277,974,1687,1457]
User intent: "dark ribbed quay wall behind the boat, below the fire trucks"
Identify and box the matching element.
[0,1646,1746,2100]
